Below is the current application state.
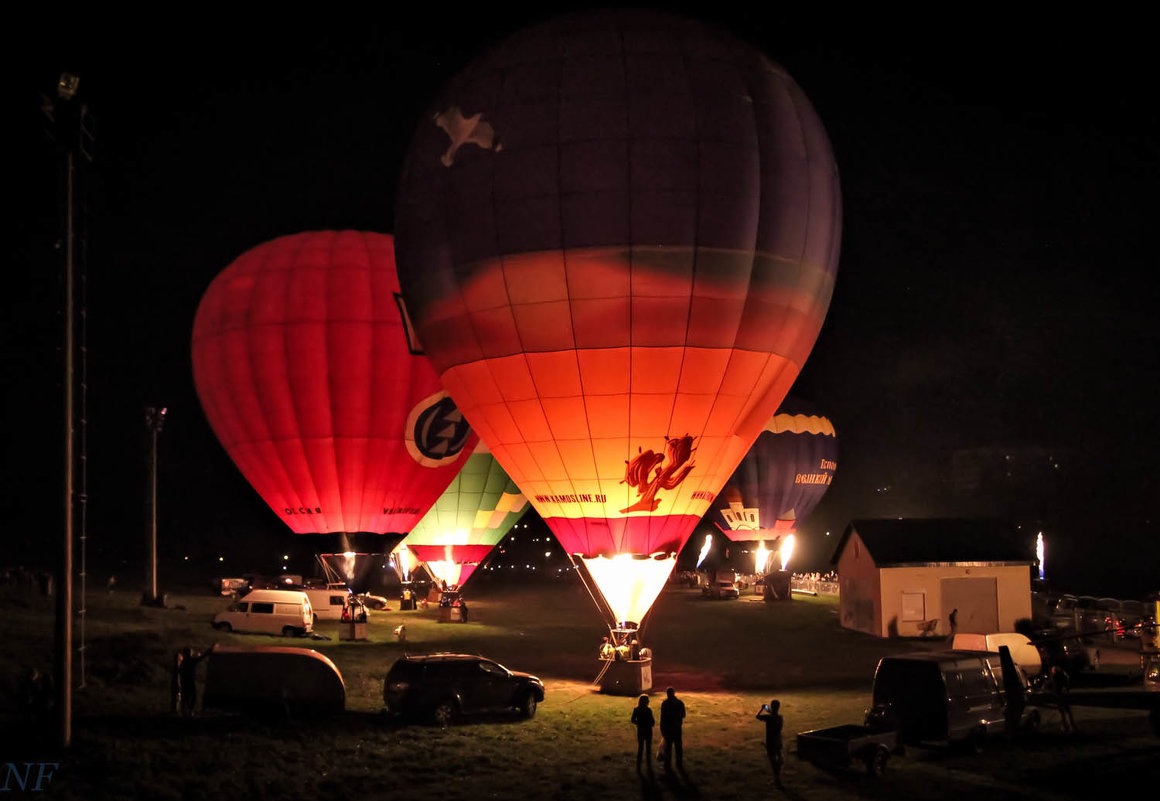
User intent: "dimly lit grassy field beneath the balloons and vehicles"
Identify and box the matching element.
[0,584,1160,801]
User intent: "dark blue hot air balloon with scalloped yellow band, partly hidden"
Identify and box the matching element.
[710,396,838,573]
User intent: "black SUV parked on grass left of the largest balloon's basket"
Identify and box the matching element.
[383,654,544,726]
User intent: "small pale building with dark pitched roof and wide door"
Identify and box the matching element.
[831,519,1034,638]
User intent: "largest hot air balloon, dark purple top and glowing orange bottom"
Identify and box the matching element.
[396,10,841,635]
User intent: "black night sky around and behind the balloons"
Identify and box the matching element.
[0,3,1160,593]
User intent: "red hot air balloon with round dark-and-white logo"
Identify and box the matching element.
[193,231,477,533]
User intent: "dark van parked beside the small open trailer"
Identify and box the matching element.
[870,651,1039,747]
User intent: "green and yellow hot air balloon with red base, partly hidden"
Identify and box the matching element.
[400,443,528,590]
